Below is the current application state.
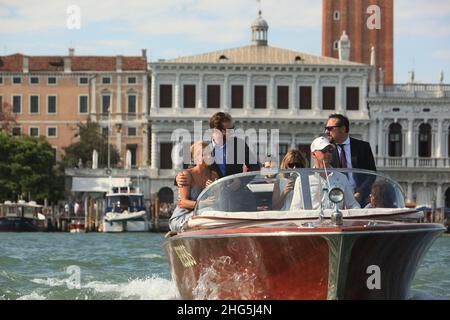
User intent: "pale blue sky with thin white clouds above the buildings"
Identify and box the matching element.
[0,0,450,83]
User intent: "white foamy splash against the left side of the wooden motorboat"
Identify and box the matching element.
[83,276,177,300]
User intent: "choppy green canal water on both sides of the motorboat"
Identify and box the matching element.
[0,233,450,300]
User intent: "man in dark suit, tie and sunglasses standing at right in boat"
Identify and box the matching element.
[325,114,377,206]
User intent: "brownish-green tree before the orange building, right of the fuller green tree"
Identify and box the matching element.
[62,121,120,168]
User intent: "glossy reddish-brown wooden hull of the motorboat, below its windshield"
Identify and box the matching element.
[164,221,444,300]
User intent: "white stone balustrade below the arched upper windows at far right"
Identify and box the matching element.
[377,157,450,169]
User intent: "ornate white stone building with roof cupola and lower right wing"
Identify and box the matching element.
[149,13,450,207]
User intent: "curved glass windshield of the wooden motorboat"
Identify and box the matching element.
[194,169,405,215]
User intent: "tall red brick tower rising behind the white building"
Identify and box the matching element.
[322,0,394,84]
